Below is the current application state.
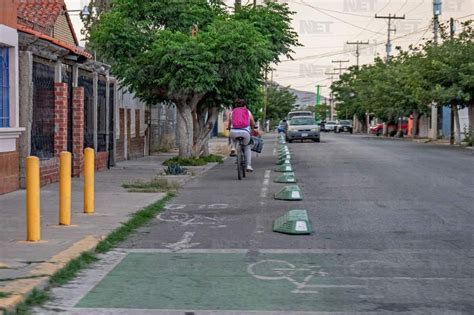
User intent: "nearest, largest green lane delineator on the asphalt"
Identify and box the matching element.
[273,209,313,234]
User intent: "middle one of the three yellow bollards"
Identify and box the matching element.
[59,152,71,225]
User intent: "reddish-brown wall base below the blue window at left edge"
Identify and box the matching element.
[0,151,20,195]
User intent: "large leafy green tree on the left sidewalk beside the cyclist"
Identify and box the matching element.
[86,0,297,157]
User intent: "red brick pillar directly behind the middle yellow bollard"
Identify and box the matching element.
[54,83,67,156]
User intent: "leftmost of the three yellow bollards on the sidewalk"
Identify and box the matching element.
[26,156,41,242]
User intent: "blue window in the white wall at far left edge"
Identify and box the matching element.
[0,47,10,128]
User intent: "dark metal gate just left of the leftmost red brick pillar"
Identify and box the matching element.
[31,61,54,159]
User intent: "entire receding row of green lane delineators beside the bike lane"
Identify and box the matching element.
[273,135,313,234]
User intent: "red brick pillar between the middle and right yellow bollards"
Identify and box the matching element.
[72,87,84,177]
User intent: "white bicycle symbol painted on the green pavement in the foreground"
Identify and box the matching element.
[247,259,366,294]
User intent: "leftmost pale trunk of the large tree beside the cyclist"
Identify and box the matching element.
[176,104,194,158]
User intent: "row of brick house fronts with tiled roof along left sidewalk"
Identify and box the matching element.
[0,0,155,194]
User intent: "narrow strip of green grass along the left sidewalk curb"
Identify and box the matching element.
[9,193,174,315]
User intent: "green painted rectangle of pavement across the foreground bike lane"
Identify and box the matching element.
[73,252,366,314]
